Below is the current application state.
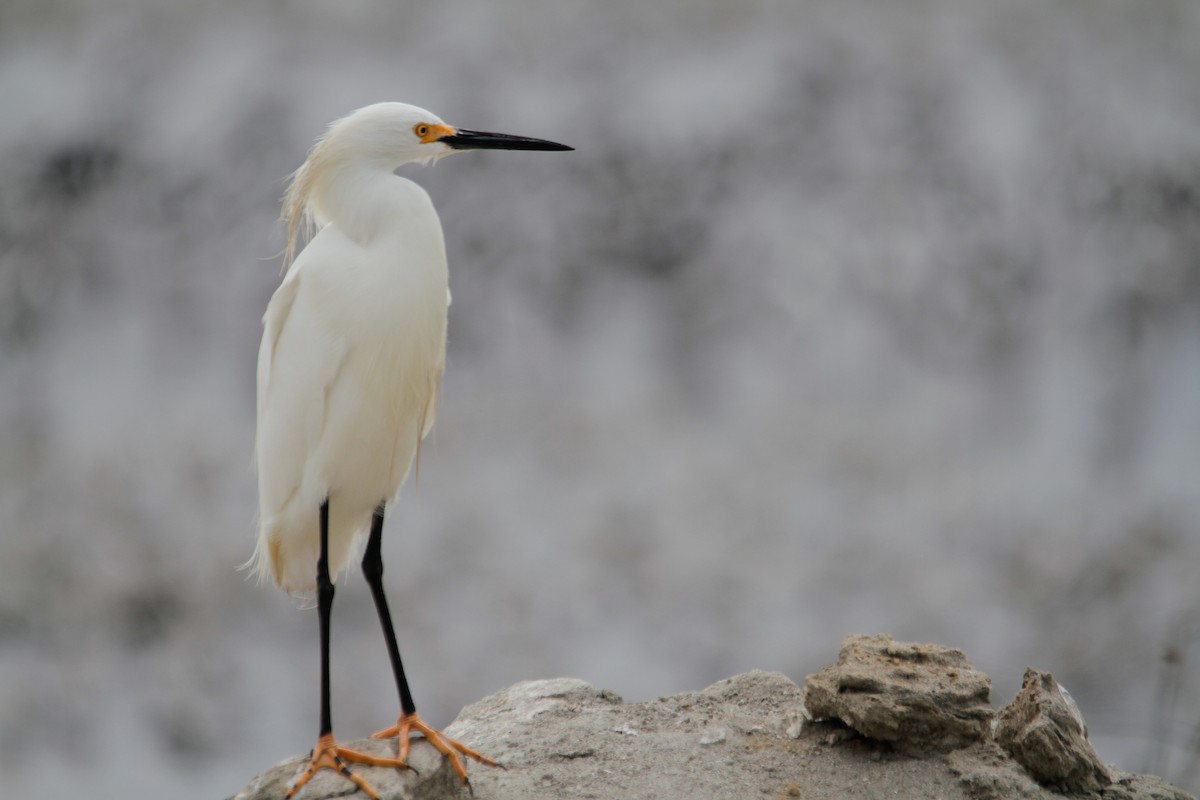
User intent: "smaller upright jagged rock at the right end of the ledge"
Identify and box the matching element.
[996,668,1112,794]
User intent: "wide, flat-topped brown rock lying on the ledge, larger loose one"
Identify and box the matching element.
[804,633,992,756]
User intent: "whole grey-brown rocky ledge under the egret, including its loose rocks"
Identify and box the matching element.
[233,634,1195,800]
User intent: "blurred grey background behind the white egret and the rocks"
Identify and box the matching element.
[0,0,1200,799]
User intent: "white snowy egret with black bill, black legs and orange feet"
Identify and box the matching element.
[248,103,572,798]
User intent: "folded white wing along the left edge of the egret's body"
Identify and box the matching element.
[254,251,346,521]
